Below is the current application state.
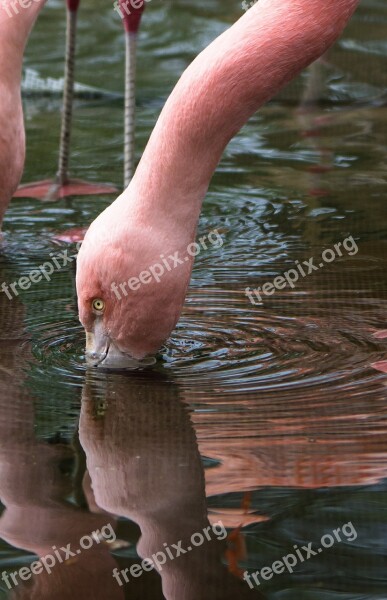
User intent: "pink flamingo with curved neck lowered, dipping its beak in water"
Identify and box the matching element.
[77,0,358,367]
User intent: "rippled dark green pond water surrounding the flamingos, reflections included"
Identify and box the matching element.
[0,0,387,600]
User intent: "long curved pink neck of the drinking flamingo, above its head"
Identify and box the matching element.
[130,0,359,237]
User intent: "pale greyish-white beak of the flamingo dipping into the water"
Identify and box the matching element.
[86,321,156,369]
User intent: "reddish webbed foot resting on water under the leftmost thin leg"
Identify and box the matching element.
[13,179,118,202]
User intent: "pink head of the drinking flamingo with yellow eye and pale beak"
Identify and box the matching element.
[77,200,193,369]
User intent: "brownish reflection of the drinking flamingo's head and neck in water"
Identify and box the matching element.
[80,374,266,600]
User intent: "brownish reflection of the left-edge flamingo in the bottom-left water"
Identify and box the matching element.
[0,278,124,600]
